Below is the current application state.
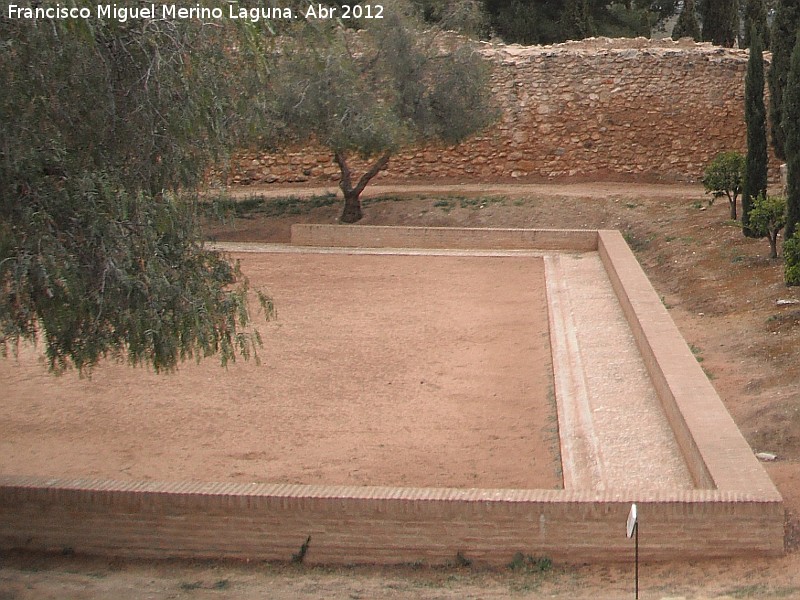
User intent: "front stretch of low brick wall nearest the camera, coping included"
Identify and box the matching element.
[0,477,783,565]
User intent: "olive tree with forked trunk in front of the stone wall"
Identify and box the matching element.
[272,6,497,223]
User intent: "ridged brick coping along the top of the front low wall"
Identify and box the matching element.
[0,475,782,504]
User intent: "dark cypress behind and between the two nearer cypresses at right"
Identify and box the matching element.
[768,0,800,159]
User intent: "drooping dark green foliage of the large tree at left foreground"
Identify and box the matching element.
[0,11,270,372]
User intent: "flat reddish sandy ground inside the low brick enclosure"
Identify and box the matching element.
[0,253,561,488]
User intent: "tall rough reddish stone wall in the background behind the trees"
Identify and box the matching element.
[229,38,778,184]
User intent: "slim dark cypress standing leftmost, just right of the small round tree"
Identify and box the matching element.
[742,26,768,237]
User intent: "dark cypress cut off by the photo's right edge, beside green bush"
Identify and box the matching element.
[783,32,800,240]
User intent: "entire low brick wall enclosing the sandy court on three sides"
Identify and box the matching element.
[0,226,784,565]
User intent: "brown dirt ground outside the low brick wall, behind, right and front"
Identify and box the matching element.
[0,183,800,599]
